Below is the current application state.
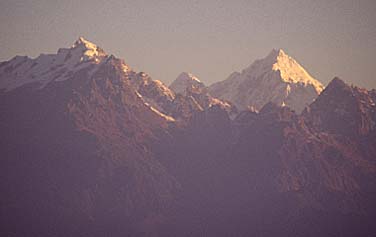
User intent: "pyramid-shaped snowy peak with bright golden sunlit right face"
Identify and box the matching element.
[209,49,323,113]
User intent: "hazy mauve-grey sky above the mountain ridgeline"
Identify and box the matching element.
[0,0,376,88]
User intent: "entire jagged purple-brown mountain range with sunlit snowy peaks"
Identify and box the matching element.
[0,37,376,236]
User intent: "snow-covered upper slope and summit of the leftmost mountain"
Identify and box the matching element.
[0,37,111,90]
